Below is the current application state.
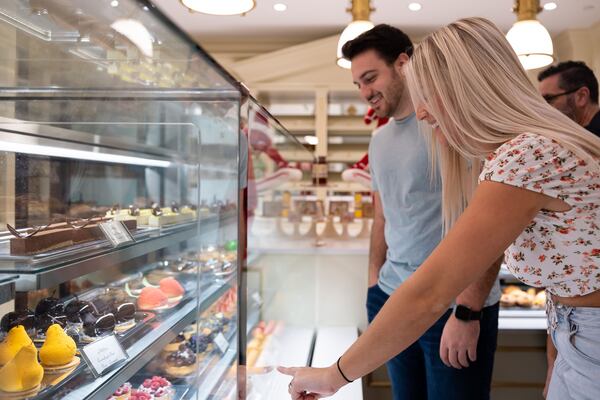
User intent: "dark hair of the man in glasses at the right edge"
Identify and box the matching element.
[538,61,598,104]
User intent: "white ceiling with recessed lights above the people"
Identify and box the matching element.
[152,0,600,44]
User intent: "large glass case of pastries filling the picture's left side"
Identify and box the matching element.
[0,0,247,400]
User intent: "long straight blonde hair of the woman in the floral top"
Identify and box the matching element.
[405,18,600,231]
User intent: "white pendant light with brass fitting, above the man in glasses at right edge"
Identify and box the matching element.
[506,0,554,69]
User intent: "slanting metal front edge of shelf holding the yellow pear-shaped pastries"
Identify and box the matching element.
[61,283,230,400]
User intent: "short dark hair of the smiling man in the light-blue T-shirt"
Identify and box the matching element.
[342,24,413,65]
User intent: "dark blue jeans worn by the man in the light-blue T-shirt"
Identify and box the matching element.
[367,285,500,400]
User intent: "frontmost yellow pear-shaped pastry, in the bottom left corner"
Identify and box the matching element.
[0,341,44,392]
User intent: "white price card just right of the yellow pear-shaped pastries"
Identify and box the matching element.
[81,335,129,377]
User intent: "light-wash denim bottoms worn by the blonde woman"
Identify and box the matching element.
[546,296,600,400]
